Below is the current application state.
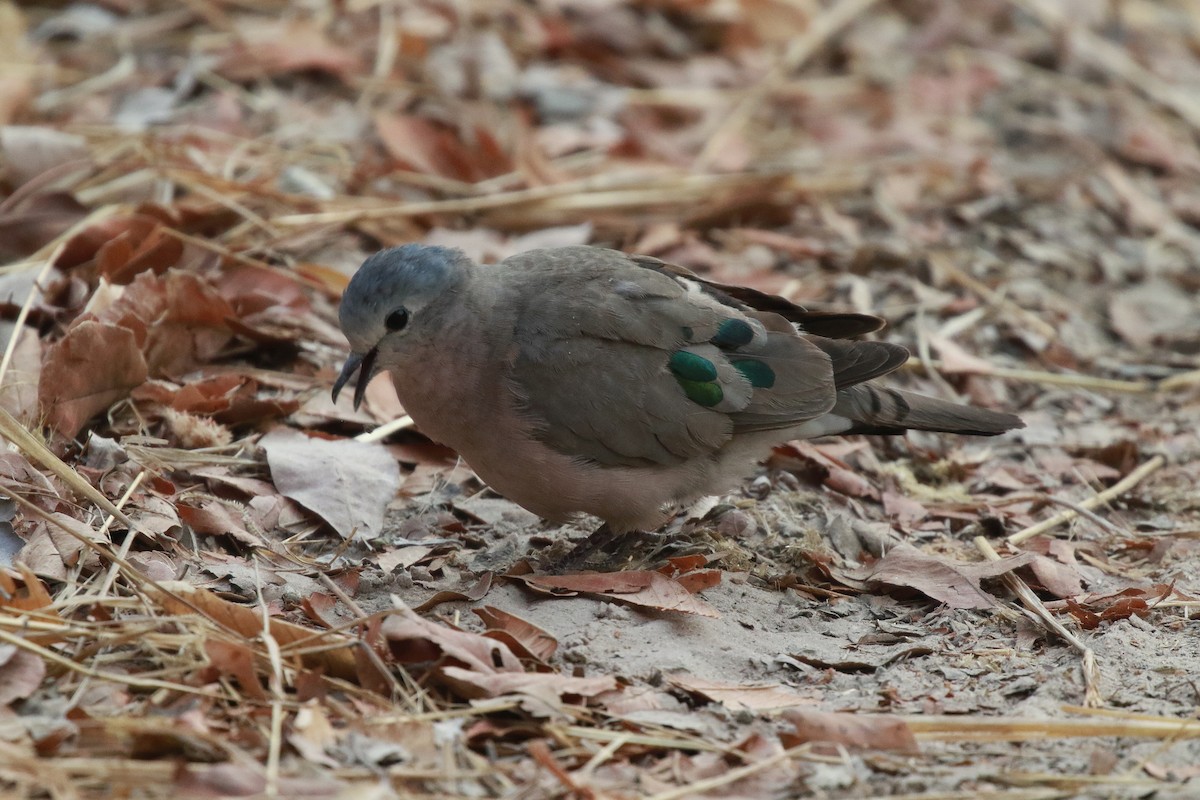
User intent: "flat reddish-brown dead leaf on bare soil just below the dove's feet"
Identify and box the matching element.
[509,570,720,619]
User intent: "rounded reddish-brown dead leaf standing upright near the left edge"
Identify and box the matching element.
[37,320,149,438]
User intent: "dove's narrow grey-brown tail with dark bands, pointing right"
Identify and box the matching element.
[830,384,1025,437]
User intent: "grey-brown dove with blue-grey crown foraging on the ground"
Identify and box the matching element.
[334,245,1024,534]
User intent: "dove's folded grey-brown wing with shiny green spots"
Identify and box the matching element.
[499,248,836,465]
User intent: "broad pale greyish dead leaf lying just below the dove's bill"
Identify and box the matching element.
[258,428,400,539]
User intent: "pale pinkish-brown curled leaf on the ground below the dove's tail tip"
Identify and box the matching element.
[830,545,1037,608]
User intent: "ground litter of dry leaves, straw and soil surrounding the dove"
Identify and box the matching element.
[0,0,1200,800]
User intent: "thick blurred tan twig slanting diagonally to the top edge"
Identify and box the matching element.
[692,0,877,173]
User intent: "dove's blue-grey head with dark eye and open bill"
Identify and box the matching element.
[334,245,472,408]
